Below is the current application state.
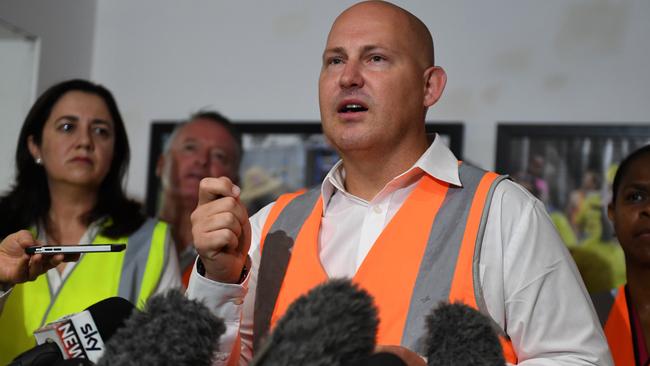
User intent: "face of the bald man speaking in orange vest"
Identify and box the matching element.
[319,5,427,154]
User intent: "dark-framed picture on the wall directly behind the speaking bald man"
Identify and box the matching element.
[146,121,464,216]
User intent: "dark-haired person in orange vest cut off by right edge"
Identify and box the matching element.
[594,145,650,366]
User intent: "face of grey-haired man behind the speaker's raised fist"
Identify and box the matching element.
[159,119,239,205]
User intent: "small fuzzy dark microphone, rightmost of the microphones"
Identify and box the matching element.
[426,303,506,366]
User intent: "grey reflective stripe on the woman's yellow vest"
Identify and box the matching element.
[117,218,159,305]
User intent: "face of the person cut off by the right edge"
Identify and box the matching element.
[608,154,650,266]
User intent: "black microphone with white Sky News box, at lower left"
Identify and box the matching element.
[10,297,134,366]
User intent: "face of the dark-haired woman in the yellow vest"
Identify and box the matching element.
[28,91,115,188]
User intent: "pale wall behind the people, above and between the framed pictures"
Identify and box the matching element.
[0,0,650,198]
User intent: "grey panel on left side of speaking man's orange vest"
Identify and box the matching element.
[253,188,320,349]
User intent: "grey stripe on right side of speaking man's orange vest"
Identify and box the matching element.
[401,164,501,354]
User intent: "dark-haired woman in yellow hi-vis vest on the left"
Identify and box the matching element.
[0,80,180,365]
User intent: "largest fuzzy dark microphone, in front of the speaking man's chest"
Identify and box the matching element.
[251,279,379,366]
